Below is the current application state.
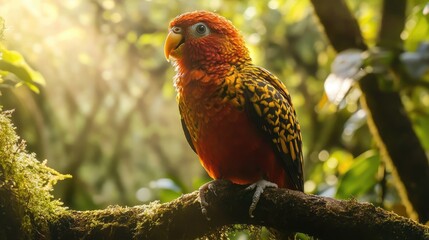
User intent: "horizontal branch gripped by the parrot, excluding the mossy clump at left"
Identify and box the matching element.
[50,181,429,240]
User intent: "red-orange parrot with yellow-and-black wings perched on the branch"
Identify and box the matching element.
[164,10,304,217]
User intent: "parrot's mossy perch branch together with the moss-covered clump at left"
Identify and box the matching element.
[0,111,429,240]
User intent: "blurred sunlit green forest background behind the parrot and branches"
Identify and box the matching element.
[0,0,429,219]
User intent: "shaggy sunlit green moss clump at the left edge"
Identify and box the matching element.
[0,108,71,239]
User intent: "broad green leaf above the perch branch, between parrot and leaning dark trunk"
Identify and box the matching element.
[336,150,380,199]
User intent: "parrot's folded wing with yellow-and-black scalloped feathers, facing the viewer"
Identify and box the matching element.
[241,66,304,191]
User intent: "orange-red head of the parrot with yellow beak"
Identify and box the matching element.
[164,11,250,72]
